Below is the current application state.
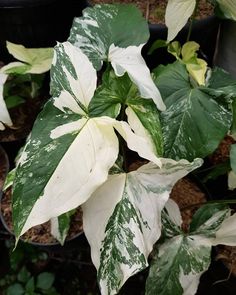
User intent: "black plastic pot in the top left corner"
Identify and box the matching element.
[0,0,88,63]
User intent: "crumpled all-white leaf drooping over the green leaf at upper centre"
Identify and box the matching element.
[108,44,165,111]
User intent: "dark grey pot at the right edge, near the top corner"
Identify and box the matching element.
[214,20,236,78]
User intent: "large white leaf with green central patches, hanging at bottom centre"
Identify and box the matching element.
[83,159,202,295]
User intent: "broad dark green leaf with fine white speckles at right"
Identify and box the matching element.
[154,61,232,161]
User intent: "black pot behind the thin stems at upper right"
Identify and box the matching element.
[143,16,220,69]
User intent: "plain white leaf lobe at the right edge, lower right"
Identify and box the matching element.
[212,213,236,246]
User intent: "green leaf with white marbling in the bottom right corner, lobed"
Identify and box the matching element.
[146,200,230,295]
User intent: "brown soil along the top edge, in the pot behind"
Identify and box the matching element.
[89,0,214,24]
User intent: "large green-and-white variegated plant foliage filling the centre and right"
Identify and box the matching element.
[5,5,236,295]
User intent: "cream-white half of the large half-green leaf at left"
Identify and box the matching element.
[21,118,118,235]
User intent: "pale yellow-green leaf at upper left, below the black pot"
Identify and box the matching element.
[1,41,53,74]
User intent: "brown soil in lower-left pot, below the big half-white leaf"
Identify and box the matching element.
[1,188,83,244]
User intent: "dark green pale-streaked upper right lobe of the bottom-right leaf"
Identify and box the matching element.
[190,204,230,237]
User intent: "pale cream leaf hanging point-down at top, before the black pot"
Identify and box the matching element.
[165,0,196,42]
